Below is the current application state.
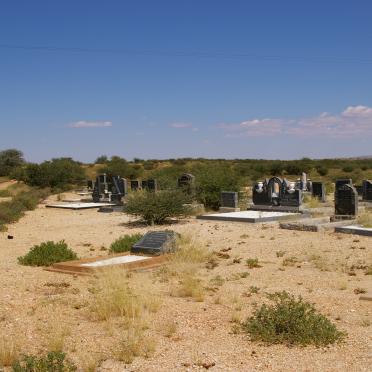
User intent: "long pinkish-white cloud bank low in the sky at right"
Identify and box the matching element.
[219,106,372,137]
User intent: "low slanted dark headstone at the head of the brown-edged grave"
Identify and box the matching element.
[130,230,177,256]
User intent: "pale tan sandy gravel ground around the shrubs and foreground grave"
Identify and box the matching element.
[0,195,372,371]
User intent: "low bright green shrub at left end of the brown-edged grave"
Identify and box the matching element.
[18,240,78,266]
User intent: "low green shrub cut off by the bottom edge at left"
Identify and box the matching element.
[13,352,77,372]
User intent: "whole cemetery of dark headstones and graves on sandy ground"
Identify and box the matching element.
[0,167,372,370]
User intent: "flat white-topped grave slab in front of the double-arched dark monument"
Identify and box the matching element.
[196,210,303,223]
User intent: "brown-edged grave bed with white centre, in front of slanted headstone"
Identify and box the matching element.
[45,252,169,275]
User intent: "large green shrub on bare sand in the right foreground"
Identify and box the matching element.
[242,291,346,346]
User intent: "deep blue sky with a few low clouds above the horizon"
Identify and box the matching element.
[0,0,372,161]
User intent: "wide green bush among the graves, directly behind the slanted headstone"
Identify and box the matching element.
[125,190,190,225]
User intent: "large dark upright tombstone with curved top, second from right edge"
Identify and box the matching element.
[335,179,358,217]
